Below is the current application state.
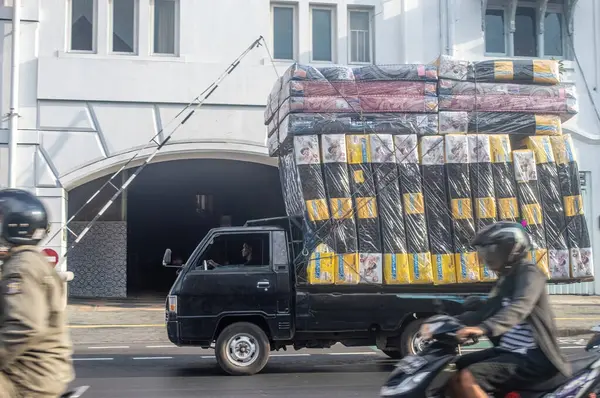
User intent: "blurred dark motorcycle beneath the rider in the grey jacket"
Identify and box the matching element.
[380,315,600,398]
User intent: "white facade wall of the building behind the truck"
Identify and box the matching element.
[0,0,600,291]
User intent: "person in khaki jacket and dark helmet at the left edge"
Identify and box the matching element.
[0,189,75,398]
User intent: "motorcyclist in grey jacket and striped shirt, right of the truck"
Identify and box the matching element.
[424,222,570,398]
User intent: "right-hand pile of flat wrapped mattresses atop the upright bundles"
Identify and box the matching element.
[438,56,578,135]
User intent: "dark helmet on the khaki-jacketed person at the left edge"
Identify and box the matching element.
[0,189,48,247]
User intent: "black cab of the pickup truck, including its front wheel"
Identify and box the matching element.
[163,219,294,374]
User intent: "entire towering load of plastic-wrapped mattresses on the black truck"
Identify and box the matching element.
[265,56,593,285]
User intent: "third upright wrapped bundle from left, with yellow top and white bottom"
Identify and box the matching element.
[346,134,383,283]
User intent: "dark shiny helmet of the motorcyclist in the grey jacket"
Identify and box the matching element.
[471,221,531,265]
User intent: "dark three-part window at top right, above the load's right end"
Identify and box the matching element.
[485,0,565,58]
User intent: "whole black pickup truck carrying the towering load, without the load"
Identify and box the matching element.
[163,217,491,375]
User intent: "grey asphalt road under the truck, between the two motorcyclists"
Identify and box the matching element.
[74,338,585,398]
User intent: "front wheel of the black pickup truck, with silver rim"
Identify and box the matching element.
[215,322,271,376]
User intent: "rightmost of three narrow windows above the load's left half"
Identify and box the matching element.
[348,10,373,64]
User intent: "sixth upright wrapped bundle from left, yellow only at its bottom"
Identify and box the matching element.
[414,136,456,284]
